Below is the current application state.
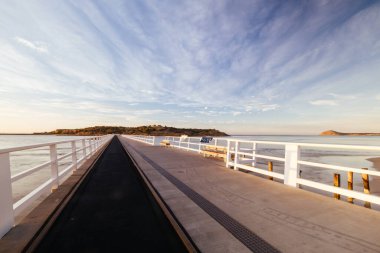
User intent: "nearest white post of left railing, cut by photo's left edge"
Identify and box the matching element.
[0,153,14,238]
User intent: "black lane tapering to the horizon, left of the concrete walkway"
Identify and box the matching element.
[36,137,186,252]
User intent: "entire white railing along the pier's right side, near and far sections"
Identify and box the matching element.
[126,136,380,209]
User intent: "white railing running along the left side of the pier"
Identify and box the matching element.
[0,135,112,238]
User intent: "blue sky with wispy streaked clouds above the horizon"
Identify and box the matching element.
[0,0,380,134]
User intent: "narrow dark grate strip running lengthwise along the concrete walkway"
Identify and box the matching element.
[132,145,279,252]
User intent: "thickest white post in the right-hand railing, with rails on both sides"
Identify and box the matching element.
[284,144,300,187]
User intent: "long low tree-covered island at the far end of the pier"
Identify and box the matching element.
[34,125,228,136]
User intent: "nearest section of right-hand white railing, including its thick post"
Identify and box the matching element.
[226,139,380,205]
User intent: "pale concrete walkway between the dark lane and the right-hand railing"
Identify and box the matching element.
[121,138,380,252]
